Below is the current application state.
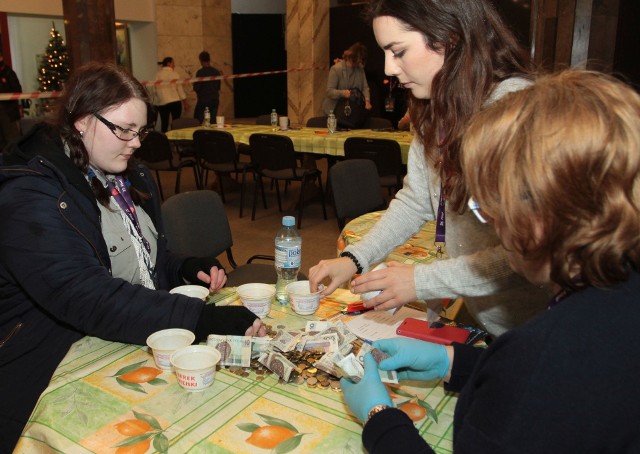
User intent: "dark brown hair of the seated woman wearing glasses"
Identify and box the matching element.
[54,62,150,206]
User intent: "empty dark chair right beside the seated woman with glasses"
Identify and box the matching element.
[162,190,278,287]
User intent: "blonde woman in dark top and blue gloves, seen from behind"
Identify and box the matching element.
[342,71,640,454]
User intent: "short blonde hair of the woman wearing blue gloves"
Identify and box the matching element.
[462,70,640,288]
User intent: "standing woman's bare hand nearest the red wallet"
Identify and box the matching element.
[351,262,416,310]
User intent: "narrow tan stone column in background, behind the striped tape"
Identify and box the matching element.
[286,0,329,126]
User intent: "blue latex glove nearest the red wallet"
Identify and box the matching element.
[373,337,449,380]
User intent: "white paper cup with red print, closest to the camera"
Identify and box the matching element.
[171,345,220,391]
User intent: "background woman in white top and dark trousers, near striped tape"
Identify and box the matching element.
[156,57,187,132]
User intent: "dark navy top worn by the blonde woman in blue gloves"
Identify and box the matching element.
[362,272,640,454]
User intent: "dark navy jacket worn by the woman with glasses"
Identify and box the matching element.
[0,124,204,452]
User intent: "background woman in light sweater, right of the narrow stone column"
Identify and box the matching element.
[322,43,371,115]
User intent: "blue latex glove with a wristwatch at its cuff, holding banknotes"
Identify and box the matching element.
[340,353,393,422]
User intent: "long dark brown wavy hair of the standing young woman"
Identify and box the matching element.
[368,0,531,212]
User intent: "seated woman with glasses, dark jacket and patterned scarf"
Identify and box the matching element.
[0,63,265,452]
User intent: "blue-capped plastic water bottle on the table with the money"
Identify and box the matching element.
[275,216,302,304]
